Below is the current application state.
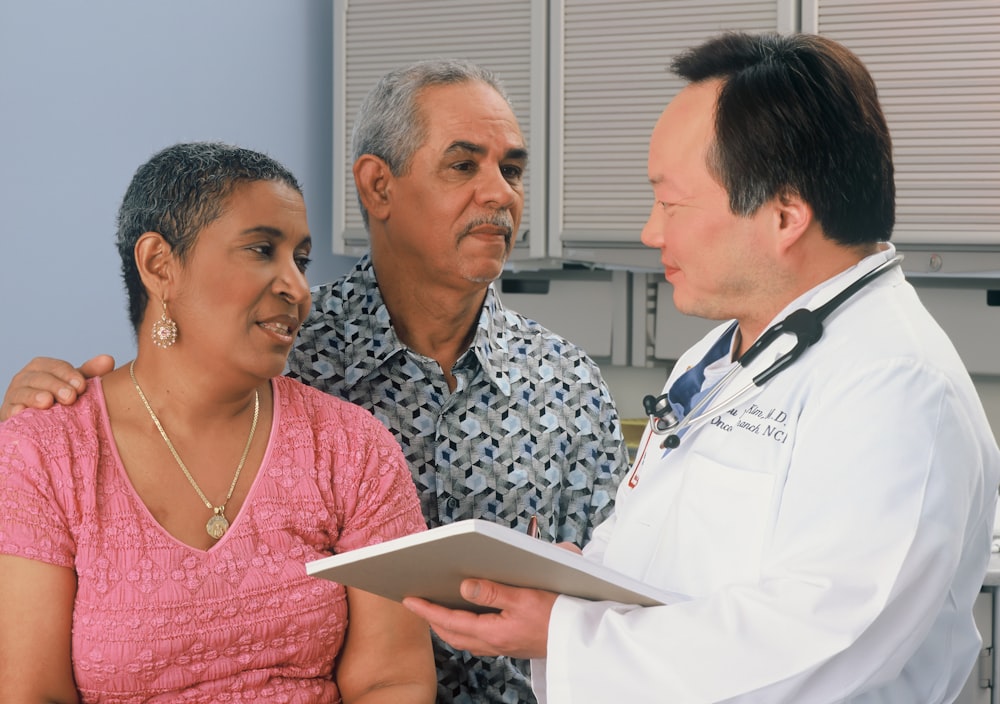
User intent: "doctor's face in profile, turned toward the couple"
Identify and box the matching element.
[642,80,767,320]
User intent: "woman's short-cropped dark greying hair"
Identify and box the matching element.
[117,142,302,333]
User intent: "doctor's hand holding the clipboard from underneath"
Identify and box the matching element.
[403,579,559,658]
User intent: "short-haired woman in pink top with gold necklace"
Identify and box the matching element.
[0,143,435,704]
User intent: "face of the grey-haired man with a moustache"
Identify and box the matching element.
[373,82,527,284]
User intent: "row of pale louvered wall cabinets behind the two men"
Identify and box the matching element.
[332,0,1000,276]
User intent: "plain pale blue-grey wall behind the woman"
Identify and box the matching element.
[0,0,353,390]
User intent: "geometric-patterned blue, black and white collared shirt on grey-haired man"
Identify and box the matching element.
[289,255,628,704]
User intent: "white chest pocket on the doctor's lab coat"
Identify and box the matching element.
[666,456,774,595]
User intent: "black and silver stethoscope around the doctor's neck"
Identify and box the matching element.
[642,254,903,449]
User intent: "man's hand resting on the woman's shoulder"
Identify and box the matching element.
[0,354,115,421]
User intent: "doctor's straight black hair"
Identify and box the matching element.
[671,32,896,245]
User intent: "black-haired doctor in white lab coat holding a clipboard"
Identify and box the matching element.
[404,34,1000,704]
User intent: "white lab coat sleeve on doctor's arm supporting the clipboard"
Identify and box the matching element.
[544,360,996,704]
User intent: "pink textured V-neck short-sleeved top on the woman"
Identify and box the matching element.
[0,377,425,703]
